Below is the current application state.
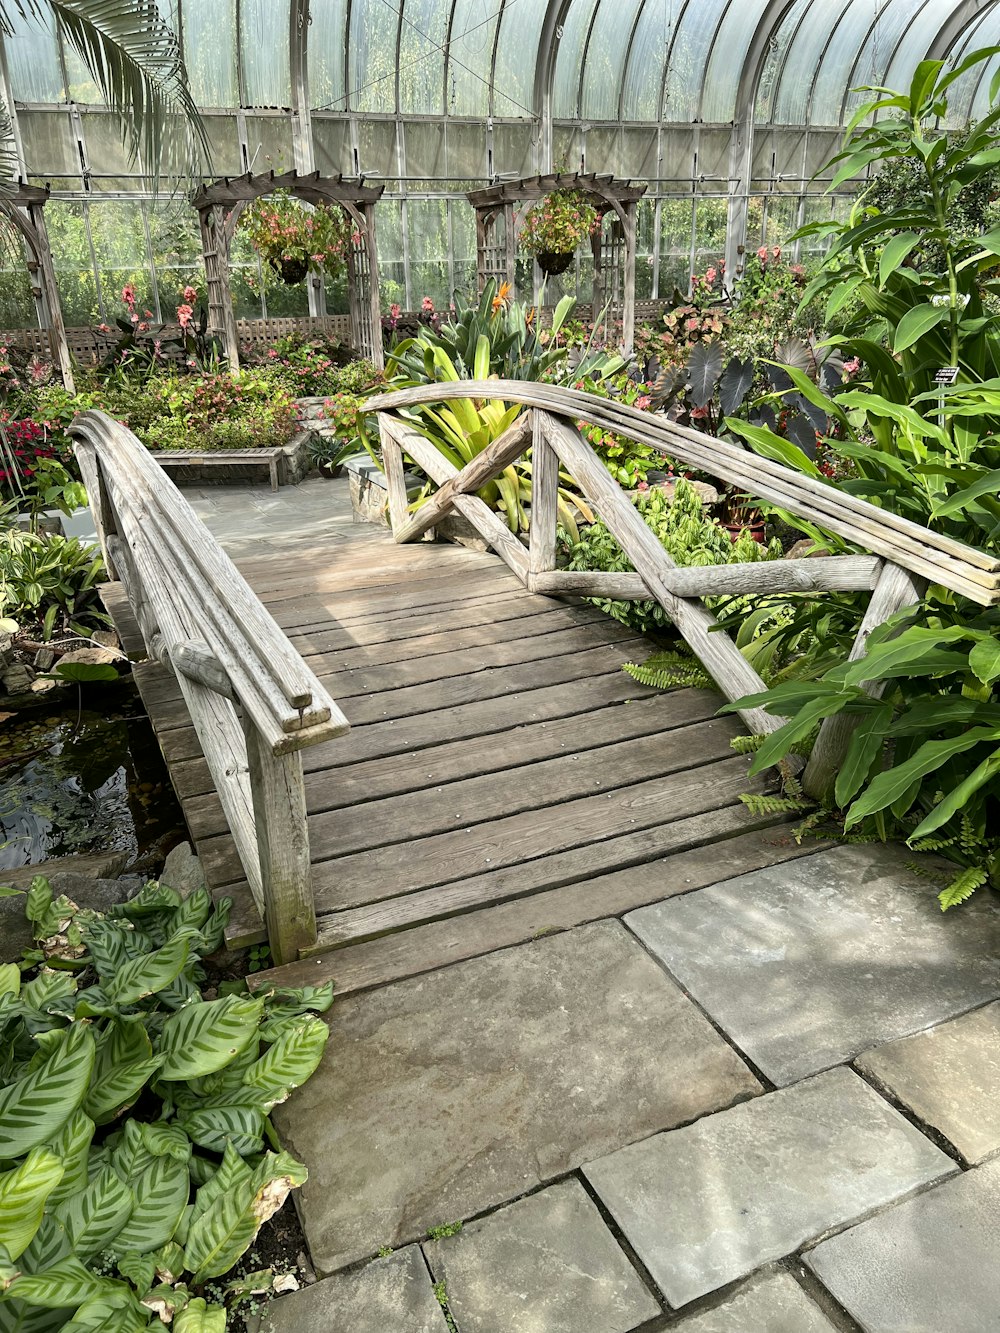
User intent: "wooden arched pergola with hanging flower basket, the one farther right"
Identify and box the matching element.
[465,172,648,352]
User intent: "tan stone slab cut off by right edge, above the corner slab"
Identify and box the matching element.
[856,1004,1000,1162]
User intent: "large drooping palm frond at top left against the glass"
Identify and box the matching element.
[50,0,211,183]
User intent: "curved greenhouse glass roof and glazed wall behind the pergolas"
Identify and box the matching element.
[0,0,1000,322]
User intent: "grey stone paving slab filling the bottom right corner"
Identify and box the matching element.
[805,1161,1000,1333]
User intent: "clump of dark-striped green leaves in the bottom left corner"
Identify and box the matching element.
[0,877,332,1333]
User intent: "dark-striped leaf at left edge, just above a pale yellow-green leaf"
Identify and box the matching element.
[0,1024,95,1161]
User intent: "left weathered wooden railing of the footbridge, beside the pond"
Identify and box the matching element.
[71,412,348,962]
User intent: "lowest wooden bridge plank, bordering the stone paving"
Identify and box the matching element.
[248,826,820,994]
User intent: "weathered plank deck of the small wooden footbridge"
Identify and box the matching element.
[105,532,801,990]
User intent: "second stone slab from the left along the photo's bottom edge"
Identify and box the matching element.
[424,1180,661,1333]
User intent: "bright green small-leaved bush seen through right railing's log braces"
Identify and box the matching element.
[561,477,781,633]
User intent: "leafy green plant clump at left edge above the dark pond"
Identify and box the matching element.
[0,528,108,639]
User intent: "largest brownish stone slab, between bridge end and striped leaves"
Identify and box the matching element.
[276,921,760,1273]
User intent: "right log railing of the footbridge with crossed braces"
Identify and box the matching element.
[365,380,1000,796]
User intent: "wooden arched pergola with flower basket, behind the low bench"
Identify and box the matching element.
[191,171,385,369]
